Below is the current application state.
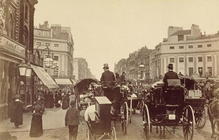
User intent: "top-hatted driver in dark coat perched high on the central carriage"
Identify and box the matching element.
[100,64,116,101]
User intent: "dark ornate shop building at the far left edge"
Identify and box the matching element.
[0,0,38,120]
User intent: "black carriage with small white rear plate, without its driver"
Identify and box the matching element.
[142,79,195,140]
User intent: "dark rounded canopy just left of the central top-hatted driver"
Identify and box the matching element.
[74,78,98,93]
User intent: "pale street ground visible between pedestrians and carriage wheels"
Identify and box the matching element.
[1,109,213,140]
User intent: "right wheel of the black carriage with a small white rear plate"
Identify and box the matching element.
[183,105,195,140]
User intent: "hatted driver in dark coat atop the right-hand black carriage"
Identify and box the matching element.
[163,64,179,88]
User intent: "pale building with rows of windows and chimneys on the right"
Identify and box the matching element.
[150,24,219,78]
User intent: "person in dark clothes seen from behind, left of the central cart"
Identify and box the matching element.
[65,100,80,140]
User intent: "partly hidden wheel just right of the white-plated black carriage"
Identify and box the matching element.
[195,107,207,129]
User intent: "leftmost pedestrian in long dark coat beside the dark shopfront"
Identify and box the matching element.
[11,95,23,128]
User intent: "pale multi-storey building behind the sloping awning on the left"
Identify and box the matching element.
[34,21,74,78]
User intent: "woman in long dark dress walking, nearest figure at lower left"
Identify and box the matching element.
[30,102,43,137]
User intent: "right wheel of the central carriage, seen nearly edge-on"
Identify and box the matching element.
[121,102,129,135]
